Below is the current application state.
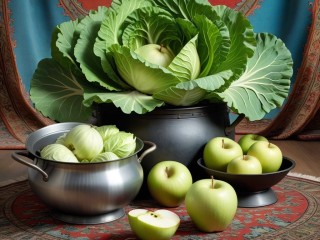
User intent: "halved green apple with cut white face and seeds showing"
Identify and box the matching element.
[128,209,180,240]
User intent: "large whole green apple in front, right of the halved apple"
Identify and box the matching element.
[185,178,238,232]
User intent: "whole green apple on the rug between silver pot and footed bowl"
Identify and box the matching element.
[147,160,192,207]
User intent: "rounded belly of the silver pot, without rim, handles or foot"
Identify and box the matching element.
[28,155,143,215]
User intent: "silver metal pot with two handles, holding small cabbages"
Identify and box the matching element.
[12,123,156,224]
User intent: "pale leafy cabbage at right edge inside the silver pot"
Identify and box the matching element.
[103,131,136,158]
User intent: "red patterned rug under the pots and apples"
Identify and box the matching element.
[0,176,320,240]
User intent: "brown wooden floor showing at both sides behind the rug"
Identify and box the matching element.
[0,139,320,186]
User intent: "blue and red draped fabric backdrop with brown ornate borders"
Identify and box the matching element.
[0,0,320,149]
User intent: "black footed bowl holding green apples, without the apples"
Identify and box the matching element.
[197,157,296,207]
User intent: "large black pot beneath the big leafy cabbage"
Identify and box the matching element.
[96,104,243,180]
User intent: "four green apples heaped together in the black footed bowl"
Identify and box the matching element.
[203,134,283,174]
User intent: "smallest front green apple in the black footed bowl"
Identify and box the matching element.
[227,155,262,174]
